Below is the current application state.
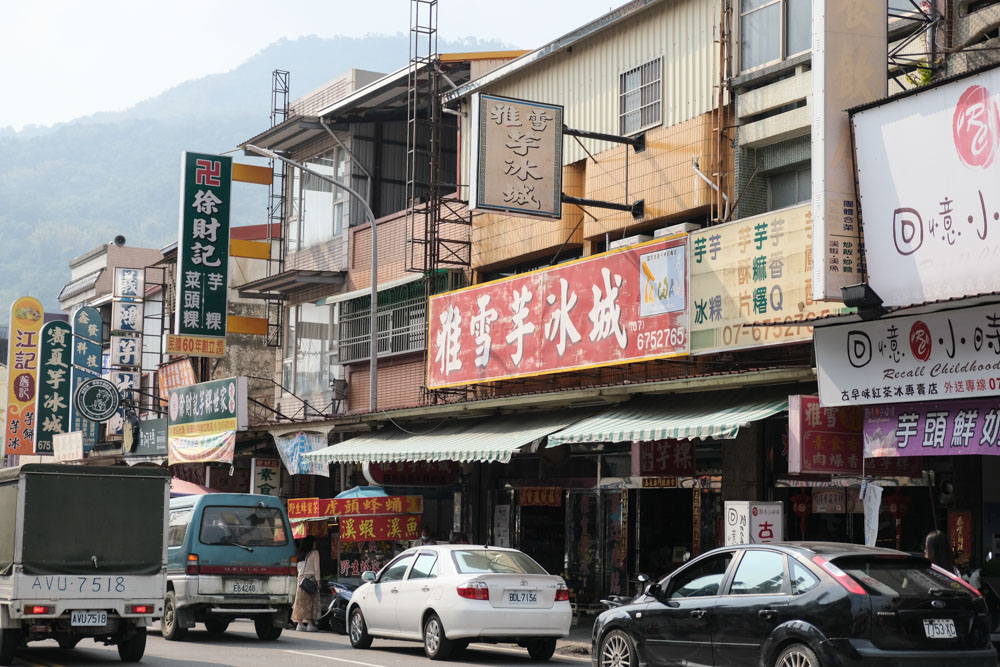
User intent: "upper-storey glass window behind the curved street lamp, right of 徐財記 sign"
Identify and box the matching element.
[288,147,348,250]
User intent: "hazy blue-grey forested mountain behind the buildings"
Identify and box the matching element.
[0,34,505,310]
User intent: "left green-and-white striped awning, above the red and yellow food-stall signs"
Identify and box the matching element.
[305,411,587,463]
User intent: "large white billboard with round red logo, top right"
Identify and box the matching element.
[852,63,1000,306]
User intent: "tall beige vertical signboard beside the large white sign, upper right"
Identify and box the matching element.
[810,0,887,301]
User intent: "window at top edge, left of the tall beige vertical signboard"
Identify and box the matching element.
[740,0,812,71]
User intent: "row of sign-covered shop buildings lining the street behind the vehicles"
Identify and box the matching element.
[6,0,1000,664]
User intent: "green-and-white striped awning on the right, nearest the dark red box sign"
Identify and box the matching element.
[548,388,788,447]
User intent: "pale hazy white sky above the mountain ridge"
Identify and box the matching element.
[0,0,625,129]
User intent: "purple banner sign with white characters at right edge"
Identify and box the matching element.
[864,398,1000,457]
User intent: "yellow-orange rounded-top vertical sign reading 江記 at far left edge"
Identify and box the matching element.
[4,296,44,455]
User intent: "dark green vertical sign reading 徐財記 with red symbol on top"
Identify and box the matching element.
[175,152,233,356]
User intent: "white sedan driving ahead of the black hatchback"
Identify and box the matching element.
[347,544,573,660]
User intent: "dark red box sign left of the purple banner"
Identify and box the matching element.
[788,395,921,477]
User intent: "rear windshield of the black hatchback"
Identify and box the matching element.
[836,558,972,597]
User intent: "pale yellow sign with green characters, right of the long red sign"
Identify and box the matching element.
[690,204,848,354]
